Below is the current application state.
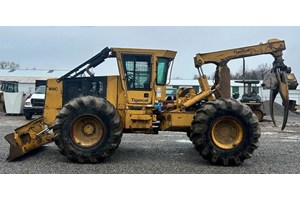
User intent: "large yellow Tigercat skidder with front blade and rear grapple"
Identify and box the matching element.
[5,40,296,165]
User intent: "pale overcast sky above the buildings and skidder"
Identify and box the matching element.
[0,26,300,79]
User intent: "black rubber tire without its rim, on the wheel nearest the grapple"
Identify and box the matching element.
[190,99,261,166]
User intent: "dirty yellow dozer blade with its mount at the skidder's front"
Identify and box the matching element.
[5,117,54,161]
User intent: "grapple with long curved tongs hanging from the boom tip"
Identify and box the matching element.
[262,55,298,130]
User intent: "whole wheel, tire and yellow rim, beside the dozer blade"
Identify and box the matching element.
[53,96,123,163]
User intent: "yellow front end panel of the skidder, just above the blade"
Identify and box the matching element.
[43,79,63,125]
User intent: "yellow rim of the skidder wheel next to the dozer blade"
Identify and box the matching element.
[71,115,105,148]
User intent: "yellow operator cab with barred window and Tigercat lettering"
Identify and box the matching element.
[111,48,176,106]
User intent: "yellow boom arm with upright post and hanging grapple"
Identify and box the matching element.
[194,39,298,130]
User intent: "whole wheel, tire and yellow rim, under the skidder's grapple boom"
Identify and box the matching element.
[190,99,260,165]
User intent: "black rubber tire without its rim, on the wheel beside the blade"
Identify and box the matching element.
[53,96,123,163]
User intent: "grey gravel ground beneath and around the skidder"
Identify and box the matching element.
[0,113,300,174]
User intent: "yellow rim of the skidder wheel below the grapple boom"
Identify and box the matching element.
[211,116,244,149]
